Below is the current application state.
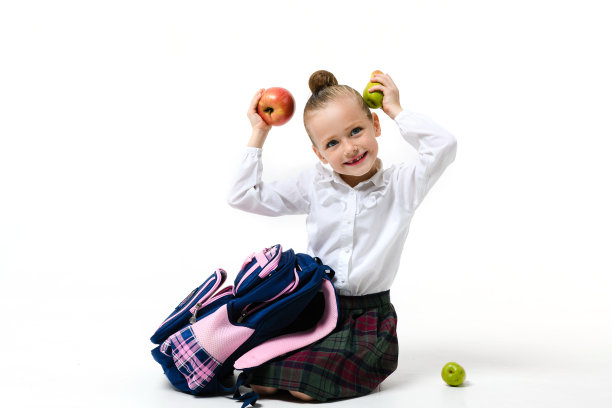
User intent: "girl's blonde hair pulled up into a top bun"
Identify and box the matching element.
[304,70,372,145]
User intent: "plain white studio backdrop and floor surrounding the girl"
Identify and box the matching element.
[0,0,612,407]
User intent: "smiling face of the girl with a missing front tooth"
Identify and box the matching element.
[307,97,380,187]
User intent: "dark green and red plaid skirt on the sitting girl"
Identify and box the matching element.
[250,291,398,401]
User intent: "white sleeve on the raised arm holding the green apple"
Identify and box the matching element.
[395,110,457,211]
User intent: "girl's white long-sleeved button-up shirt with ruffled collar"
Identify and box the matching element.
[228,110,457,296]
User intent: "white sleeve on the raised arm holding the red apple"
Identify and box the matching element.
[227,147,310,217]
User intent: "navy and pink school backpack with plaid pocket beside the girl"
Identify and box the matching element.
[151,245,338,407]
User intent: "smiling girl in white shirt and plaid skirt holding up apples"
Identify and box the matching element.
[228,71,456,401]
